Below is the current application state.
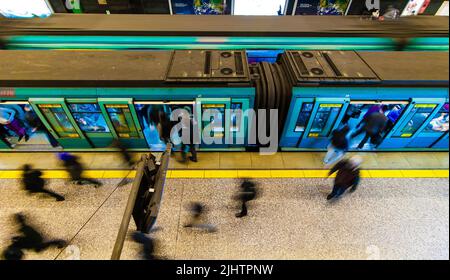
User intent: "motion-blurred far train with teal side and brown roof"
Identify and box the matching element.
[0,14,449,56]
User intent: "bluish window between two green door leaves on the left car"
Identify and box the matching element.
[69,103,110,133]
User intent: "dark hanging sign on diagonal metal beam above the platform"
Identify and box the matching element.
[111,144,172,260]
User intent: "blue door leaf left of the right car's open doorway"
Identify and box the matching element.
[299,98,349,149]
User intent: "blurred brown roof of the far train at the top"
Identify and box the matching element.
[0,14,449,37]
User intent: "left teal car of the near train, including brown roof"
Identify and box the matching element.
[0,50,255,150]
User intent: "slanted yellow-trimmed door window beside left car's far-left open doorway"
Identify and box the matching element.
[38,104,80,138]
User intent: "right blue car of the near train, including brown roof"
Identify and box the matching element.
[280,51,449,150]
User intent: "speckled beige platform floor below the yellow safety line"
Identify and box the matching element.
[0,178,449,259]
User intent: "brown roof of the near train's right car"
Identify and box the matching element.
[278,51,449,86]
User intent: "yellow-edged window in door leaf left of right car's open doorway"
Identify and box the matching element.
[309,104,342,137]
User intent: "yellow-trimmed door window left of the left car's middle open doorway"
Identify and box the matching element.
[106,104,139,138]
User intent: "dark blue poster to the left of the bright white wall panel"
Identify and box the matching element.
[172,0,224,15]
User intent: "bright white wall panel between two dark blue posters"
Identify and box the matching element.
[233,0,286,16]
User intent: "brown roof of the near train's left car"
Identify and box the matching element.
[0,50,250,87]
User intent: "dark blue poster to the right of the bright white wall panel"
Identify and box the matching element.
[295,0,350,15]
